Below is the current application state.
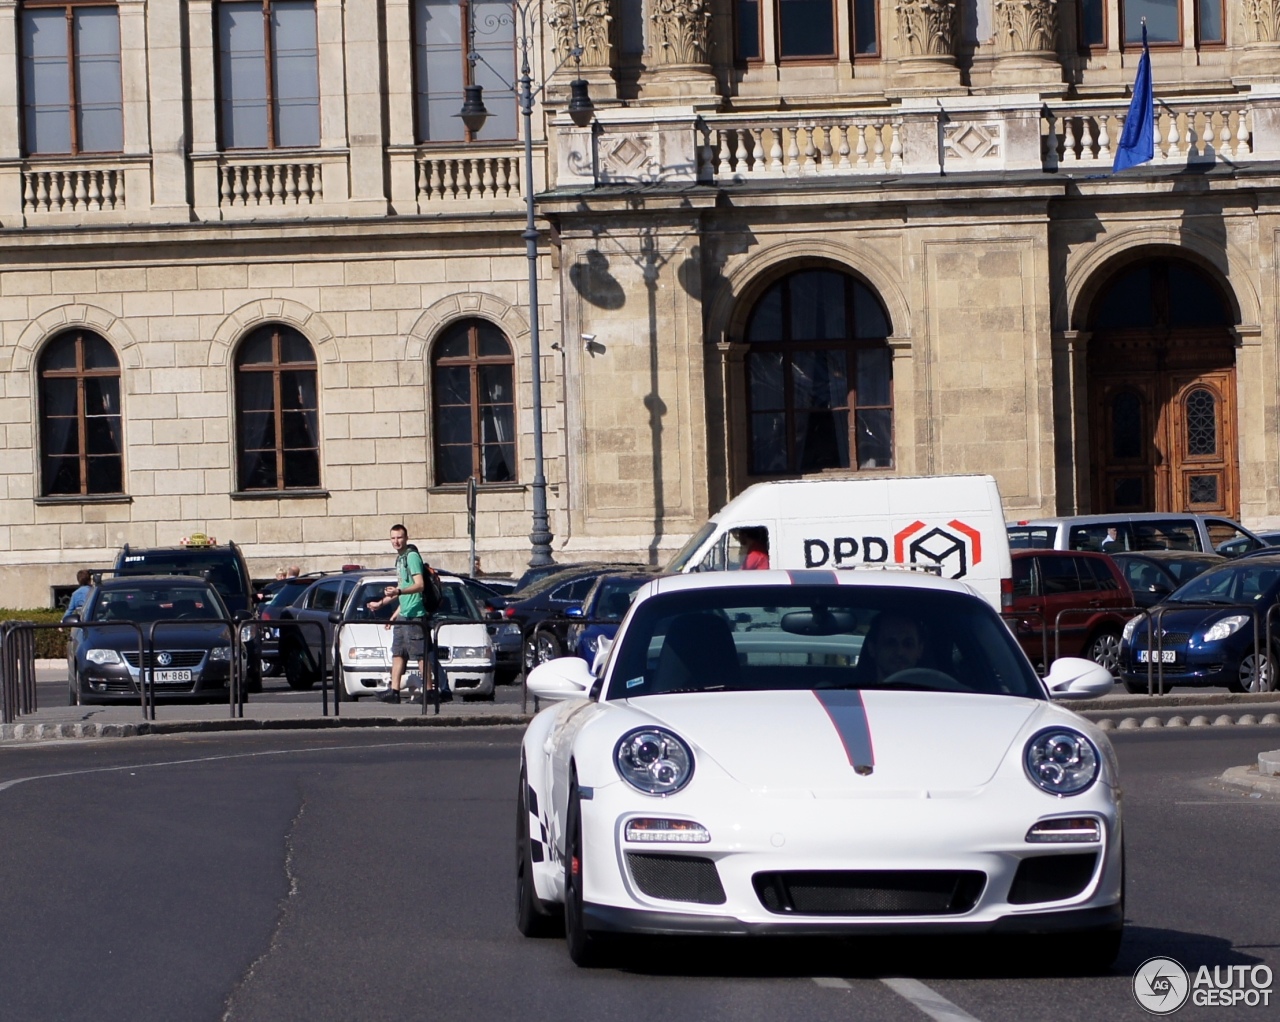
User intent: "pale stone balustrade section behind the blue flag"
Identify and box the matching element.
[1041,97,1254,170]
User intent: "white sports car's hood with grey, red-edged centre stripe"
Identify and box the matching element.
[630,689,1047,798]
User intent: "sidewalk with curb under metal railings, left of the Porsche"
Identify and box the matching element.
[0,661,534,743]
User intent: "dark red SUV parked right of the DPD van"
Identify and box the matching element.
[1005,549,1135,674]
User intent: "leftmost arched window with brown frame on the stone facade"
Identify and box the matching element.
[40,330,124,497]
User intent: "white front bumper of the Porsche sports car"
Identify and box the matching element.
[565,775,1123,935]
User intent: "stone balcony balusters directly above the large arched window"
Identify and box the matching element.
[699,111,904,184]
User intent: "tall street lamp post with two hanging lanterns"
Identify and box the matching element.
[458,0,595,567]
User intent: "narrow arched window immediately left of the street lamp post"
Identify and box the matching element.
[431,319,516,485]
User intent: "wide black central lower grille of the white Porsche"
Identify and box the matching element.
[753,870,987,916]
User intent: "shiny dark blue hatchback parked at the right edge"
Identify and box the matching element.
[1120,553,1280,693]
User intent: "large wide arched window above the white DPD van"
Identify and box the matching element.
[746,270,893,475]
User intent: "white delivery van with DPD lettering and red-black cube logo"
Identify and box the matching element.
[667,475,1012,611]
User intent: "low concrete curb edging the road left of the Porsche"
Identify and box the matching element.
[0,713,532,742]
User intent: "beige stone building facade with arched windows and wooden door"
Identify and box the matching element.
[0,0,1280,606]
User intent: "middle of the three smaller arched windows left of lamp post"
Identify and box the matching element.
[236,323,320,491]
